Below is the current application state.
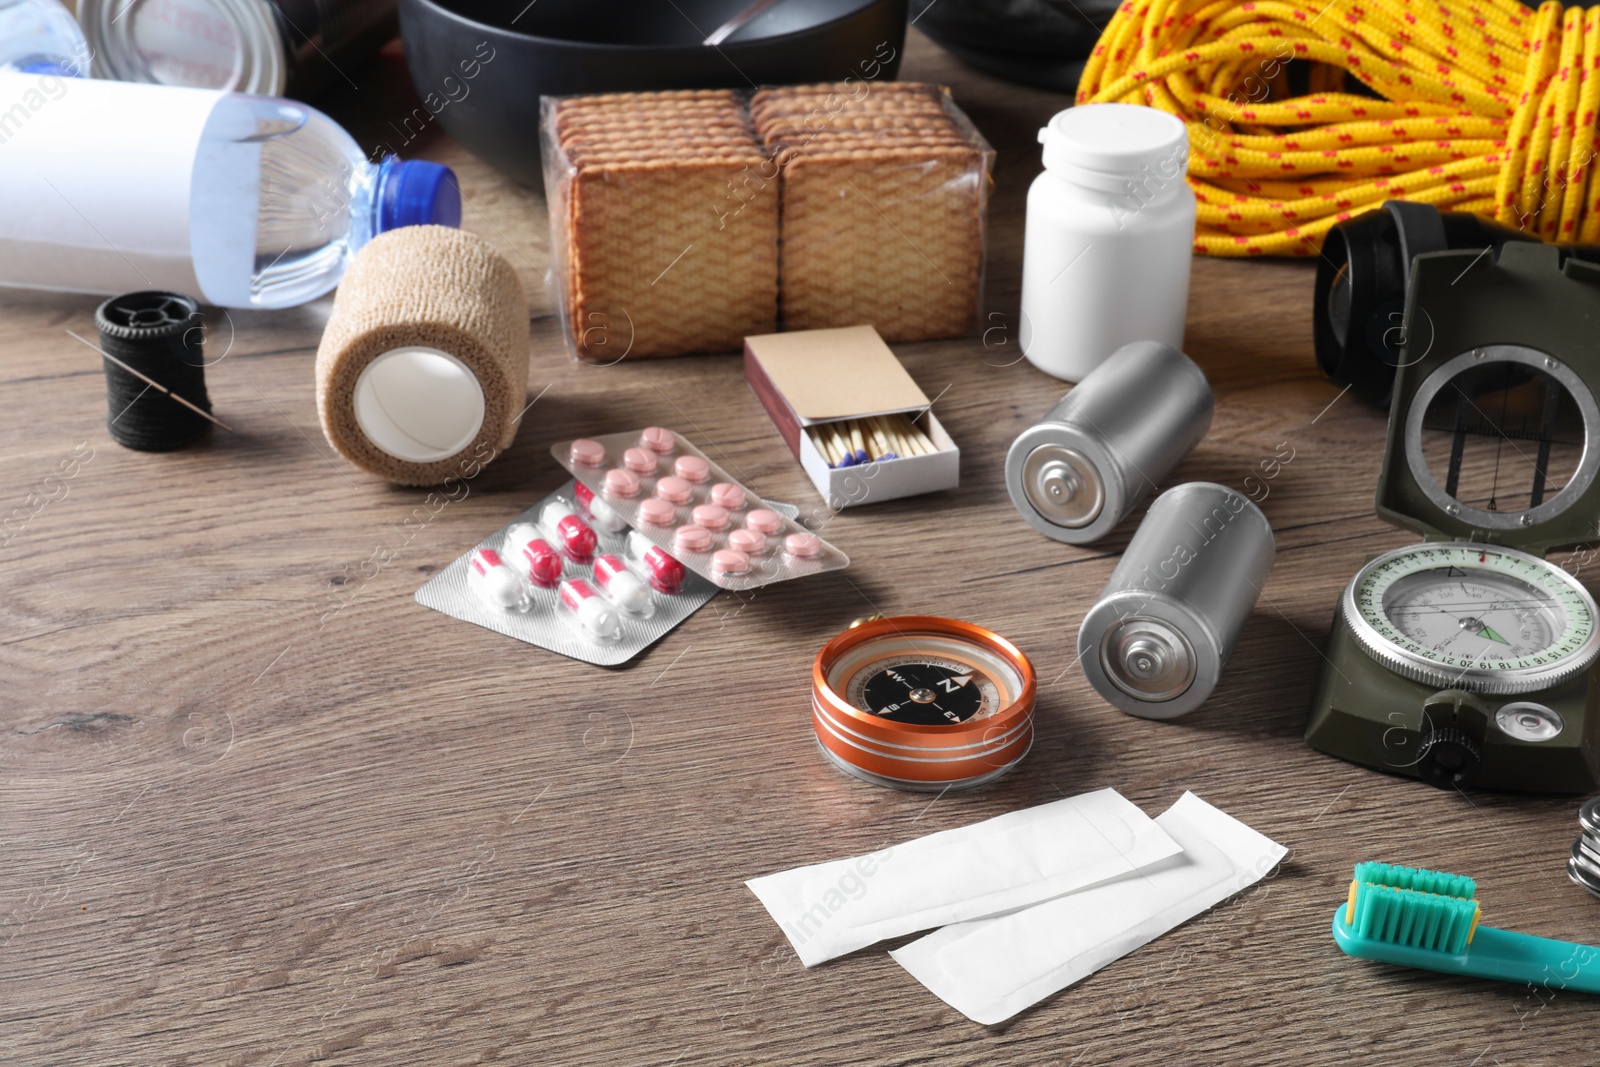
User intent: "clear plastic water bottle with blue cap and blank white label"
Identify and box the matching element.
[0,72,461,307]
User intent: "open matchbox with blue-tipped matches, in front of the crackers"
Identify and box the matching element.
[744,326,962,510]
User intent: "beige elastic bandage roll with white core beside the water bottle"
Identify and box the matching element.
[317,226,528,485]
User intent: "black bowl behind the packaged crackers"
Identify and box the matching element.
[400,0,907,186]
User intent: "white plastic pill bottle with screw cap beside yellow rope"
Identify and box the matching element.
[1019,104,1195,382]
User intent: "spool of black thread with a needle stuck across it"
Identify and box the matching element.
[94,291,211,453]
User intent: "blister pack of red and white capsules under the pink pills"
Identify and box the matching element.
[416,482,718,667]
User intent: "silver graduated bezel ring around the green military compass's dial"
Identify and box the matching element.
[1339,541,1600,696]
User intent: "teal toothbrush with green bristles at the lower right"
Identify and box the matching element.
[1333,864,1600,993]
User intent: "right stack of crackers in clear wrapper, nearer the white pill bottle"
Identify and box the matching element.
[750,82,994,344]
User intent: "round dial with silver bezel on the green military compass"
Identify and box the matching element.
[1344,542,1600,694]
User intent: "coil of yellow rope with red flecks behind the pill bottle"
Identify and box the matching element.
[1077,0,1600,256]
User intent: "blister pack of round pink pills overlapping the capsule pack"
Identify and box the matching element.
[550,426,850,590]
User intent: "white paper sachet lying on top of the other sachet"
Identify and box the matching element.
[744,789,1179,966]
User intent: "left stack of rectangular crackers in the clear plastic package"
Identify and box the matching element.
[539,90,778,363]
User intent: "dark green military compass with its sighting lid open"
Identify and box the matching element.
[1306,243,1600,793]
